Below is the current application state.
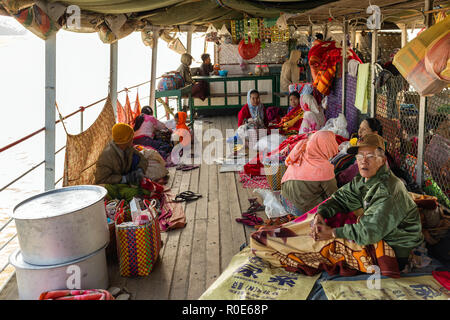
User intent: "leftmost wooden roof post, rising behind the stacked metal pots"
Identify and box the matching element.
[44,34,56,191]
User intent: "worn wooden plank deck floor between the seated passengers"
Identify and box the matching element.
[0,115,265,300]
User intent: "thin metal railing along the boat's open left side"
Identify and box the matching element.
[0,81,156,292]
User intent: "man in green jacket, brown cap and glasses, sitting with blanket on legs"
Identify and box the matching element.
[311,134,423,270]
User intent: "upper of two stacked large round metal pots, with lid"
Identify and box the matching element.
[12,185,109,265]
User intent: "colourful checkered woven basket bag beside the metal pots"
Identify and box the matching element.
[116,200,161,277]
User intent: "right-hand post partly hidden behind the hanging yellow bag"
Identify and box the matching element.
[416,0,433,187]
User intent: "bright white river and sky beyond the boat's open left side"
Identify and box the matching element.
[0,16,212,288]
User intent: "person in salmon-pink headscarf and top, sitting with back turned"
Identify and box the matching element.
[281,131,338,212]
